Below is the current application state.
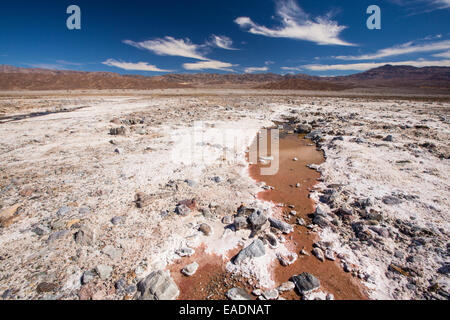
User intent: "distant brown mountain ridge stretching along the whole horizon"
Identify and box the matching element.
[0,65,450,90]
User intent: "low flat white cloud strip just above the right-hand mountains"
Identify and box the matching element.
[303,60,450,71]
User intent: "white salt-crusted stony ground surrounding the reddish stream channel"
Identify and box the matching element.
[0,90,450,299]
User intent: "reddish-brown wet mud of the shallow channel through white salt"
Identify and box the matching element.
[250,130,367,300]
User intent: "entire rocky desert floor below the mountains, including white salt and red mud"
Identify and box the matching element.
[0,89,450,300]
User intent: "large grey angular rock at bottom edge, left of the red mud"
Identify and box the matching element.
[136,271,180,300]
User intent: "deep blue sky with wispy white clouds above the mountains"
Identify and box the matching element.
[0,0,450,76]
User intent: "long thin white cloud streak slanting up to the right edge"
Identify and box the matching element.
[335,40,450,60]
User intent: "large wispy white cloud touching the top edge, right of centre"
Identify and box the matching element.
[235,0,353,46]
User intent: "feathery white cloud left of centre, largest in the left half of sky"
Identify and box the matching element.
[123,37,208,60]
